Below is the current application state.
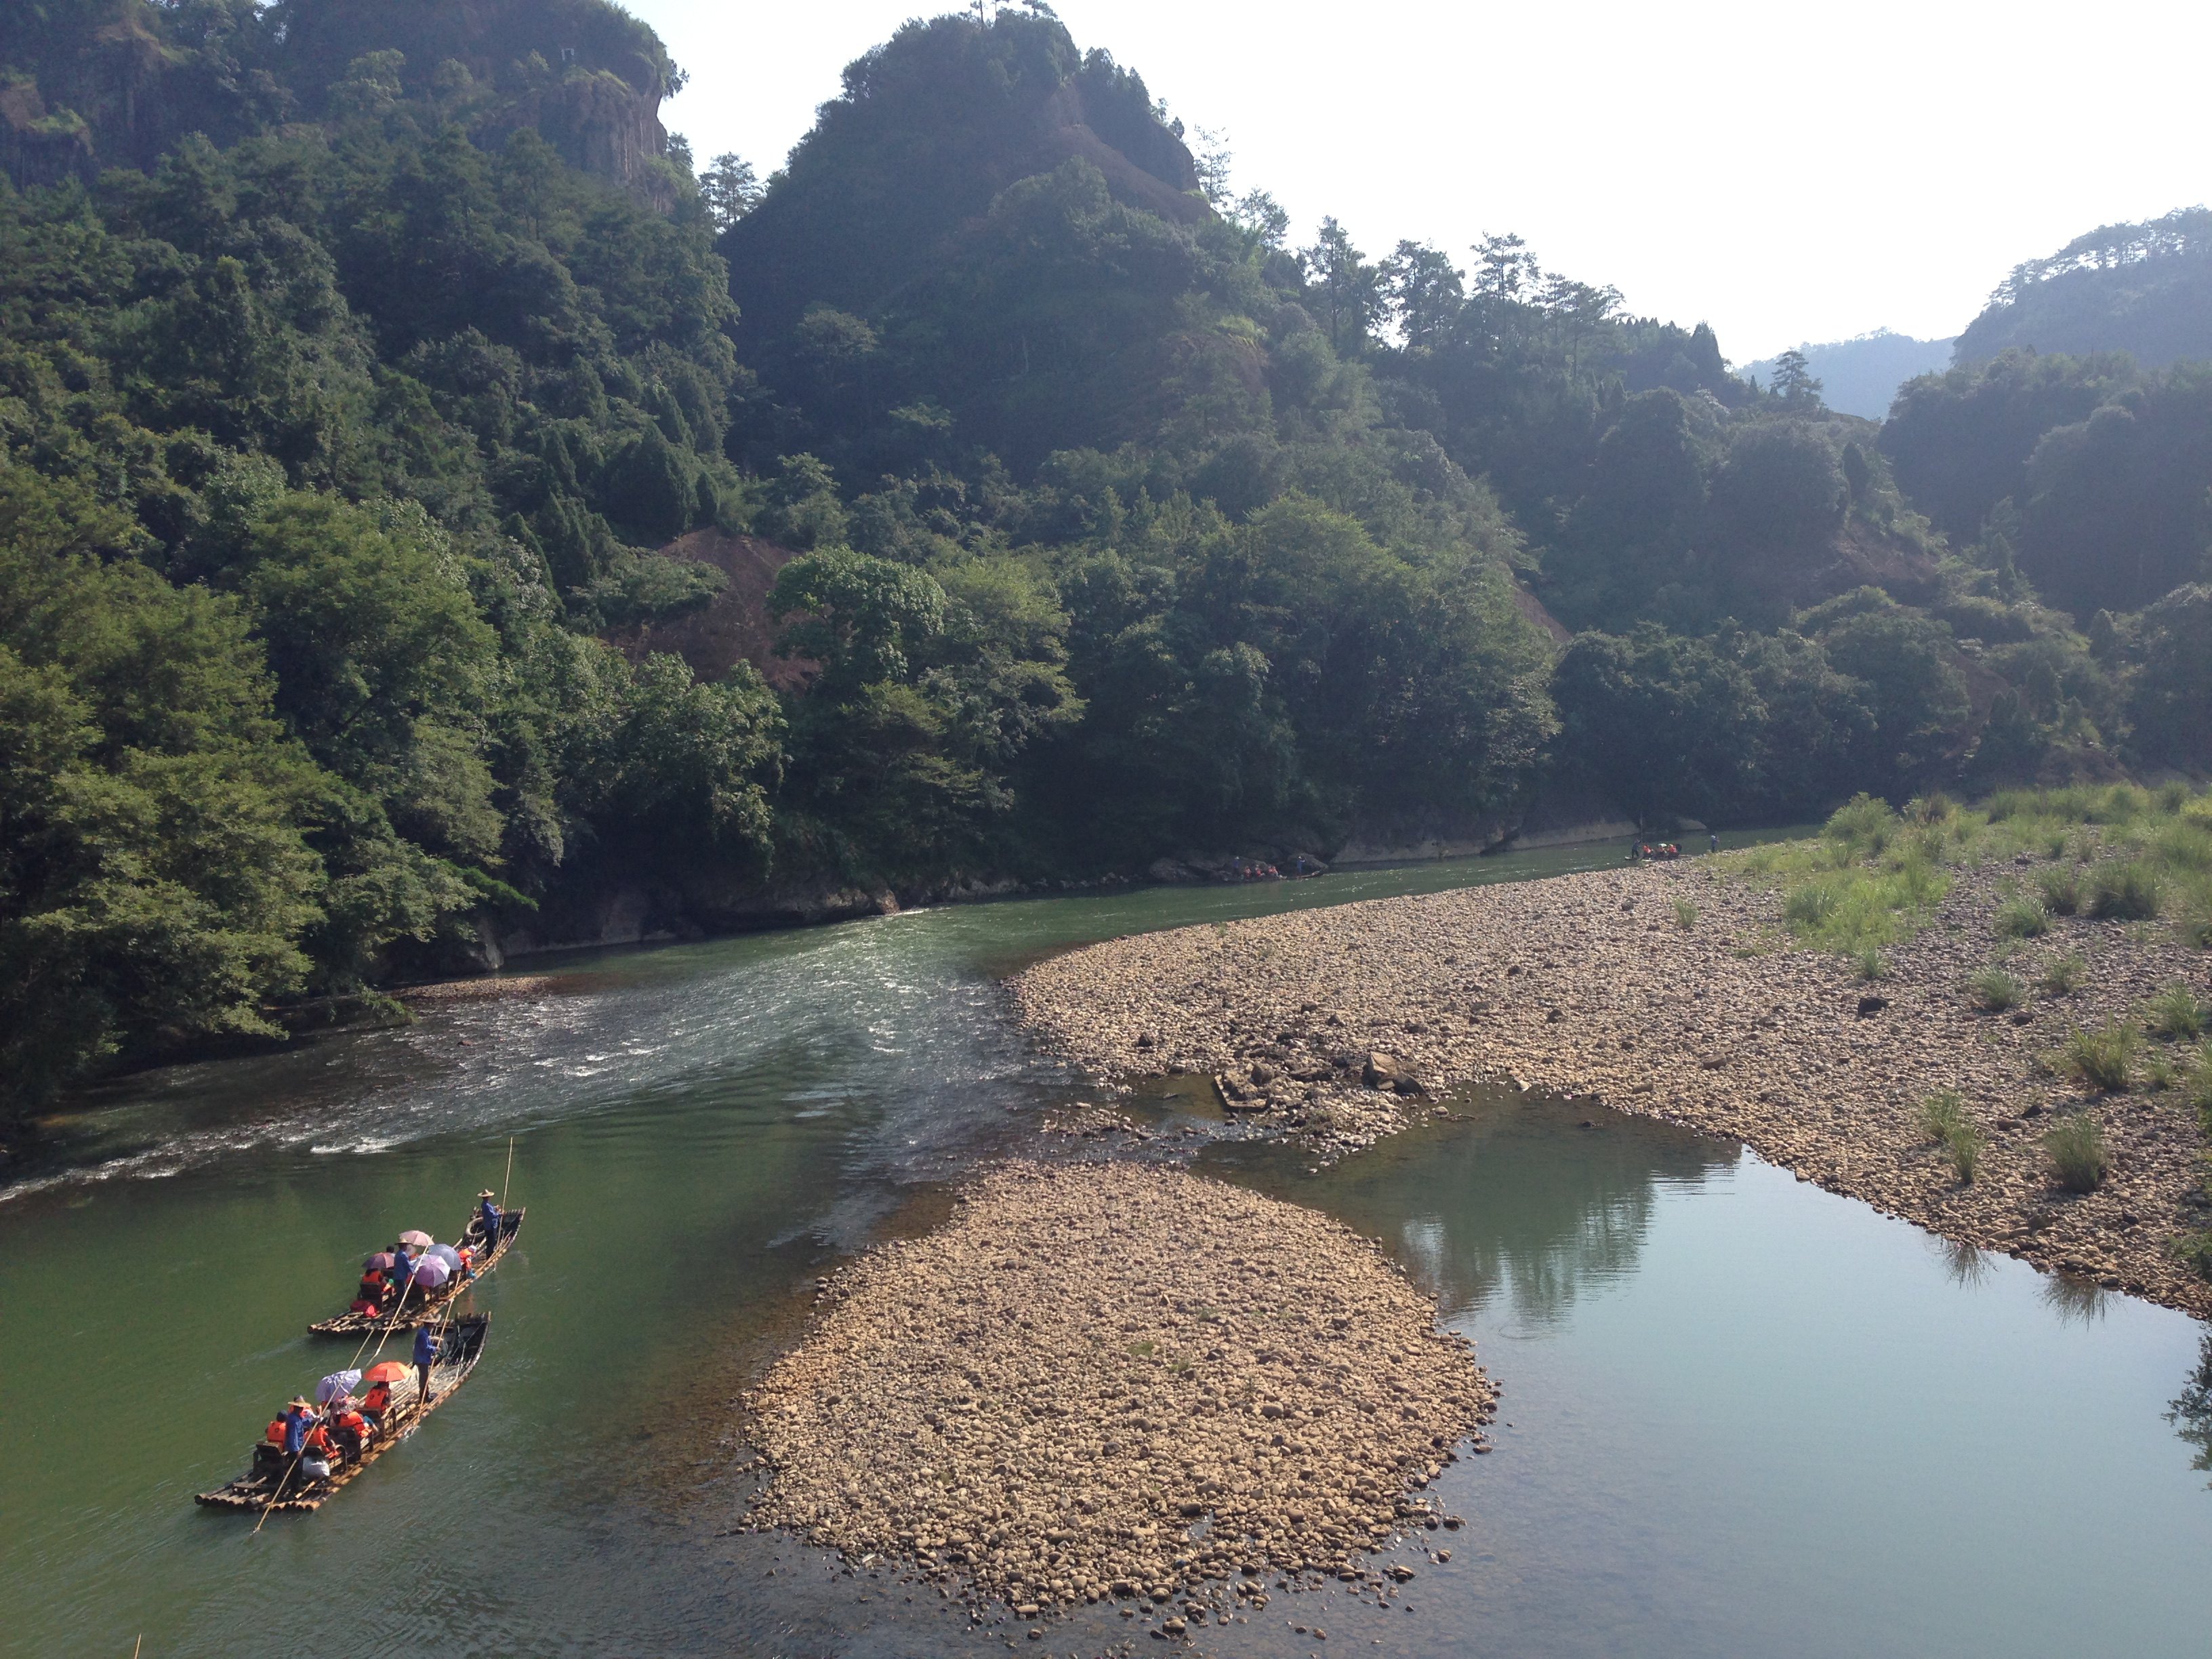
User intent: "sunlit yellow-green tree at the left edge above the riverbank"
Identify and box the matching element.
[0,467,325,1106]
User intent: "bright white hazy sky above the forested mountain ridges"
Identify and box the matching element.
[628,0,2212,363]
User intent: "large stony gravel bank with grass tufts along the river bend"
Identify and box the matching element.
[1008,861,2212,1318]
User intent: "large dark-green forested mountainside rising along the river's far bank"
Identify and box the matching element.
[0,0,2212,1141]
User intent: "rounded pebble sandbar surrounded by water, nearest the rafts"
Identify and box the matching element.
[747,1164,1493,1617]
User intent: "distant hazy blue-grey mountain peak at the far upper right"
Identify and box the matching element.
[1958,208,2212,369]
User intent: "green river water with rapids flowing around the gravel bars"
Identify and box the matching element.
[0,847,2212,1659]
